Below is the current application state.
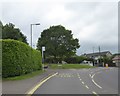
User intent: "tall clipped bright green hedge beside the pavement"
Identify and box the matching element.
[0,39,42,77]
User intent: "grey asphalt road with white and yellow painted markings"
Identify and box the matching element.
[34,67,118,95]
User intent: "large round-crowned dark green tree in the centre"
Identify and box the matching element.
[37,25,80,60]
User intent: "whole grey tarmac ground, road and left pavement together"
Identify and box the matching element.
[2,67,118,96]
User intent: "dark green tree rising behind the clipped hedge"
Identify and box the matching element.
[2,23,28,44]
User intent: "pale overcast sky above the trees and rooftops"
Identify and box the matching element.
[0,0,118,55]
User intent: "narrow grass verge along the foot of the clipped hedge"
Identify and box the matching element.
[2,70,45,81]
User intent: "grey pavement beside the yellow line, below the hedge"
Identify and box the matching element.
[2,69,56,94]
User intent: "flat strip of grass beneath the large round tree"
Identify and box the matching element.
[50,64,95,69]
